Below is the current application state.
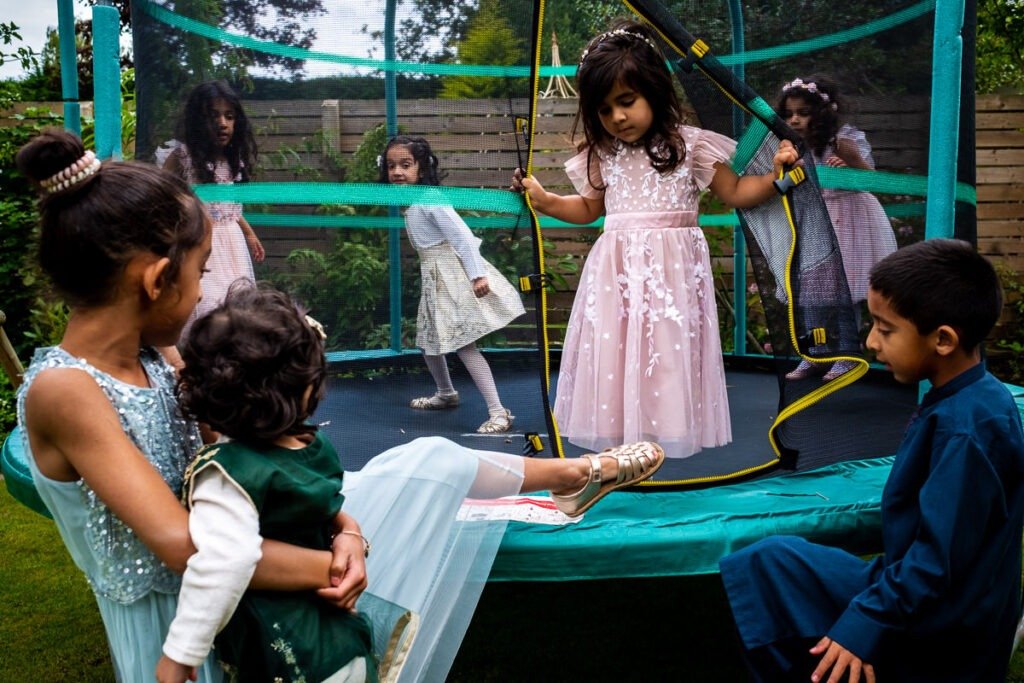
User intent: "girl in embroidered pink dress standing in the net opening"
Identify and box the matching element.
[512,23,797,458]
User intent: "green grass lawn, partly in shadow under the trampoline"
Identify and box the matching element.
[0,485,1024,683]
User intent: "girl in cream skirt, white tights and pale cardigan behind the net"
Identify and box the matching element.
[380,135,526,434]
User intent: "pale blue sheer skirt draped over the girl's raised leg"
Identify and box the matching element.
[342,437,522,682]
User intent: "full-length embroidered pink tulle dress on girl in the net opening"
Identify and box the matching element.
[554,126,735,458]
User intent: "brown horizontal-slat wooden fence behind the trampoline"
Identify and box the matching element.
[6,95,1024,282]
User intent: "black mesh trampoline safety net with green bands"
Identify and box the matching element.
[132,0,974,487]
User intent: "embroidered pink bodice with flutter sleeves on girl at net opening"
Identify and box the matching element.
[565,126,736,216]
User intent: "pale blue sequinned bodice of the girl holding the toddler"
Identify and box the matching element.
[17,346,200,603]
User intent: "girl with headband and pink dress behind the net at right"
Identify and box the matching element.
[777,76,896,381]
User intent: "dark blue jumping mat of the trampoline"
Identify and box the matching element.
[315,358,918,489]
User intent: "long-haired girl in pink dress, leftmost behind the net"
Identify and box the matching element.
[164,81,265,339]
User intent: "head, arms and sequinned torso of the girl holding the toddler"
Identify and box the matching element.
[17,130,361,681]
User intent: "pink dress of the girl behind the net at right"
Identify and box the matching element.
[814,125,896,302]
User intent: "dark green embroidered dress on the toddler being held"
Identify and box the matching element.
[185,434,376,683]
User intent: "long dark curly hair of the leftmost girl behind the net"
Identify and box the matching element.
[176,81,258,182]
